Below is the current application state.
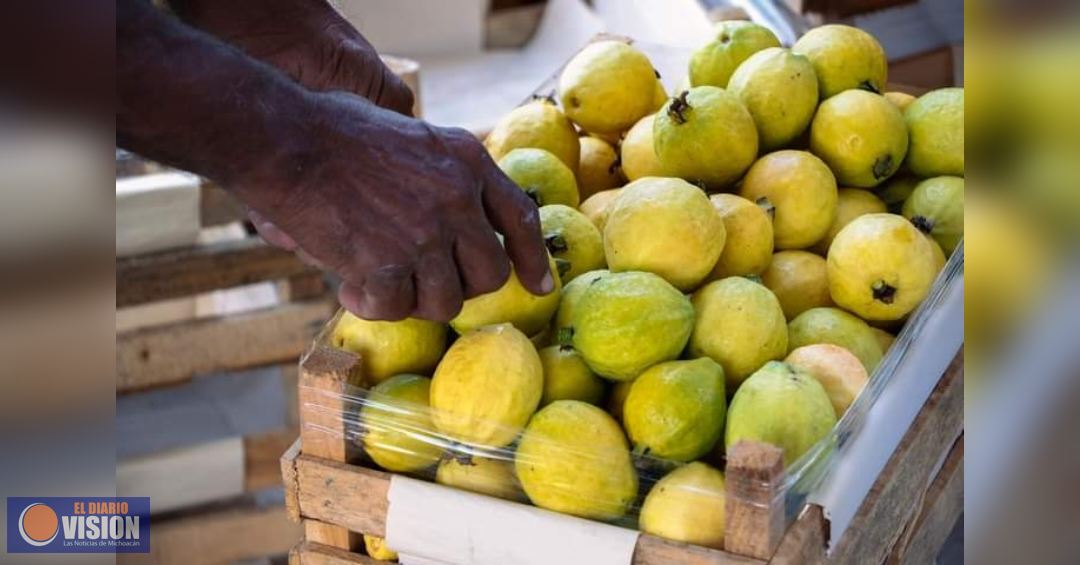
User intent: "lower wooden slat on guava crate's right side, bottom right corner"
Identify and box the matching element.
[887,435,963,565]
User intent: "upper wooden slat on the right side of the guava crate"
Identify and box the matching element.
[831,350,963,564]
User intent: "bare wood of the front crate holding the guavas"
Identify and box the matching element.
[281,347,963,565]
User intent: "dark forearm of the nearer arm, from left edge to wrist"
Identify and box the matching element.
[117,0,312,193]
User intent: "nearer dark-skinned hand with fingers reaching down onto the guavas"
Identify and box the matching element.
[237,93,554,321]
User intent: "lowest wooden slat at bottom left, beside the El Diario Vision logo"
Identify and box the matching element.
[117,507,302,565]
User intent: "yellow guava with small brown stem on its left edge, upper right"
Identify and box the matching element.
[739,149,837,250]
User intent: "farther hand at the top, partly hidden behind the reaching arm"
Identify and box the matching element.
[171,0,413,116]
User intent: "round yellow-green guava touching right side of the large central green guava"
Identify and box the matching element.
[690,277,787,390]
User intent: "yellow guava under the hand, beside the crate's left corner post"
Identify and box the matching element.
[330,312,446,385]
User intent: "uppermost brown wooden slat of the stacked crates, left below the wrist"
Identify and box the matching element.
[116,237,316,308]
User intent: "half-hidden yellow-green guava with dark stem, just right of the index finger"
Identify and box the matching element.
[540,204,604,284]
